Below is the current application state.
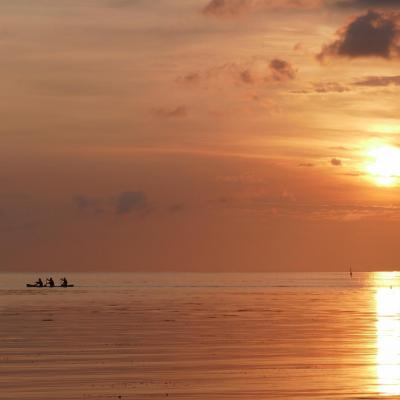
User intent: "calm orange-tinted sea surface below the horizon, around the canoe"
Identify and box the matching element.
[0,273,400,400]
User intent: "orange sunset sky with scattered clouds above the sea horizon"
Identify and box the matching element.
[0,0,400,272]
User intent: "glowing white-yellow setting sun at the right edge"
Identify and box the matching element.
[366,145,400,186]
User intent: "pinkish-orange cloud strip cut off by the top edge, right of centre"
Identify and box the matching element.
[202,0,321,18]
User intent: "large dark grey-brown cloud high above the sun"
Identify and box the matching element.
[317,11,400,61]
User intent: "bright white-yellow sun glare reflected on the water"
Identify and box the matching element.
[376,273,400,396]
